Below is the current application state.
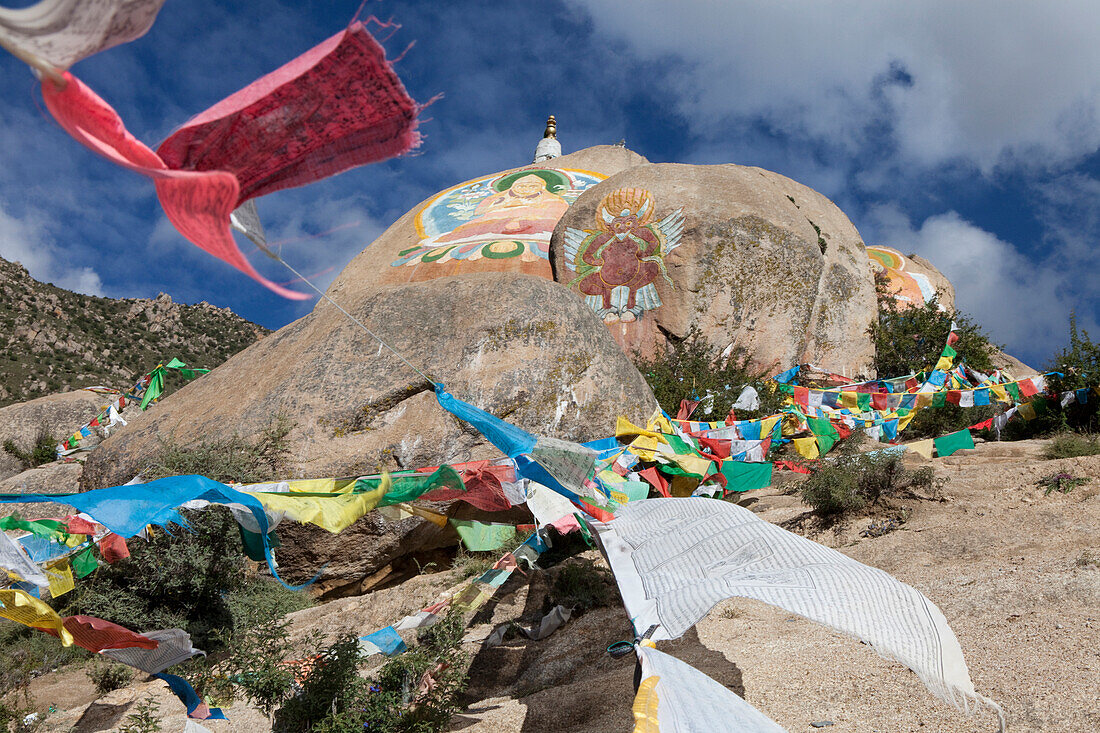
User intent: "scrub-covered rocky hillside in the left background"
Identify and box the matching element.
[0,259,268,406]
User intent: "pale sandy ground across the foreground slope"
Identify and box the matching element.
[19,441,1100,733]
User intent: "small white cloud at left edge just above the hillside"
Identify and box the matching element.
[0,205,103,296]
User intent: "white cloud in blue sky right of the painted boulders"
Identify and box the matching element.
[868,206,1073,360]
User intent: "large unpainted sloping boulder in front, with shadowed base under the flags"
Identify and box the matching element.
[81,273,656,593]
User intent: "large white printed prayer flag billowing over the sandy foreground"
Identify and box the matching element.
[593,499,1003,730]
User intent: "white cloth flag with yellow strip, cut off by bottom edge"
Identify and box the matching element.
[634,644,784,733]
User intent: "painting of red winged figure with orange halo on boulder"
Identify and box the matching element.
[564,188,684,324]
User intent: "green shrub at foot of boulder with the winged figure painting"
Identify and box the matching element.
[634,326,782,420]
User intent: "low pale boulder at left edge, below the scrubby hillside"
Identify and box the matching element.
[0,390,103,479]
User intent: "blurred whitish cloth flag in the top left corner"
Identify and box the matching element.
[0,0,164,72]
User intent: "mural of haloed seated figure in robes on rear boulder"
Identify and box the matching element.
[389,168,606,281]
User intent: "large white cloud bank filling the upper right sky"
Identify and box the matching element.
[571,0,1100,172]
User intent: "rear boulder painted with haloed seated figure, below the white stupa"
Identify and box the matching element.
[369,145,648,287]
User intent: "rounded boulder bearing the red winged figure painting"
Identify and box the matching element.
[551,163,876,374]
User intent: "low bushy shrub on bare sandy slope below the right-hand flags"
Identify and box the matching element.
[799,451,935,517]
